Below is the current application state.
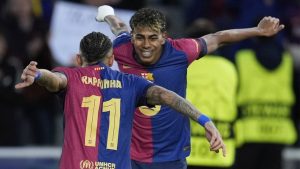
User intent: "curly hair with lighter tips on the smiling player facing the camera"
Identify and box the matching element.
[130,8,167,32]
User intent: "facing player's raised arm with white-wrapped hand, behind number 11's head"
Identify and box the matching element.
[96,5,129,36]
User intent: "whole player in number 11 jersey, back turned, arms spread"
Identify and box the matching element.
[15,32,226,169]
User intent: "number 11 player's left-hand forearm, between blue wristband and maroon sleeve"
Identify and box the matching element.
[35,69,64,92]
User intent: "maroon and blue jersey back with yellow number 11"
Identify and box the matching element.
[55,64,151,169]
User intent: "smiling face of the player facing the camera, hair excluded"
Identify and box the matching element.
[132,27,165,65]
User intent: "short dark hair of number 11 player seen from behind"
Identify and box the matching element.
[80,32,112,63]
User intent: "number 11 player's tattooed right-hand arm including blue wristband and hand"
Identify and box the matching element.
[146,86,226,156]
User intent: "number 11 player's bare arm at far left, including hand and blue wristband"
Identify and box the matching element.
[15,61,67,92]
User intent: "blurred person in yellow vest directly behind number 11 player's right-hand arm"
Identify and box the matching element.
[187,18,238,169]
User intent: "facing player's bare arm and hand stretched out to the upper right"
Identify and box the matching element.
[202,16,284,53]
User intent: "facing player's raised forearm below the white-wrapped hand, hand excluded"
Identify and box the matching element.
[104,15,128,36]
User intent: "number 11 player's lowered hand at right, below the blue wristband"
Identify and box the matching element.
[204,121,226,157]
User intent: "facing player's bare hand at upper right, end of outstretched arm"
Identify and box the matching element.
[257,16,284,37]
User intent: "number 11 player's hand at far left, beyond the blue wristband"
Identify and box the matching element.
[15,61,38,89]
